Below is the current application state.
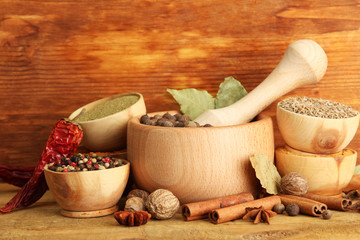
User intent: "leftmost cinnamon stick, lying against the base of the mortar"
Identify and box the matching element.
[181,192,254,221]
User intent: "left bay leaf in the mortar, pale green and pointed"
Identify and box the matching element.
[167,88,215,120]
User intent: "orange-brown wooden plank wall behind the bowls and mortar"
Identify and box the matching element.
[0,0,360,165]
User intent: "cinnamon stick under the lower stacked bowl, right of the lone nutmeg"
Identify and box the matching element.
[303,193,352,211]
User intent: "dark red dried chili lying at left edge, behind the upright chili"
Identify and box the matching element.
[0,164,35,187]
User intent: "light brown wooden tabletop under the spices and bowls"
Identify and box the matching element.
[0,184,360,240]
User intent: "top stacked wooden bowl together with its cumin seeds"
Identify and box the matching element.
[276,97,360,154]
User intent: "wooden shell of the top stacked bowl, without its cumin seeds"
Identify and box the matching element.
[276,104,360,154]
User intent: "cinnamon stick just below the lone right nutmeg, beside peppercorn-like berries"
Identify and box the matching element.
[279,194,327,217]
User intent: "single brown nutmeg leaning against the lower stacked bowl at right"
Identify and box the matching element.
[280,172,309,196]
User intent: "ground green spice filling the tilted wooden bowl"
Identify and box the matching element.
[79,95,139,122]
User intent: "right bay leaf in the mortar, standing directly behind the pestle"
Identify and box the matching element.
[215,77,247,108]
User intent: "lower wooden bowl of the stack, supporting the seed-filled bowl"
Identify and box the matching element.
[275,146,357,195]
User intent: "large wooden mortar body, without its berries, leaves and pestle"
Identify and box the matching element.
[127,113,274,203]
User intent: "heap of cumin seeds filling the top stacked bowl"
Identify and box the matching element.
[279,97,359,119]
